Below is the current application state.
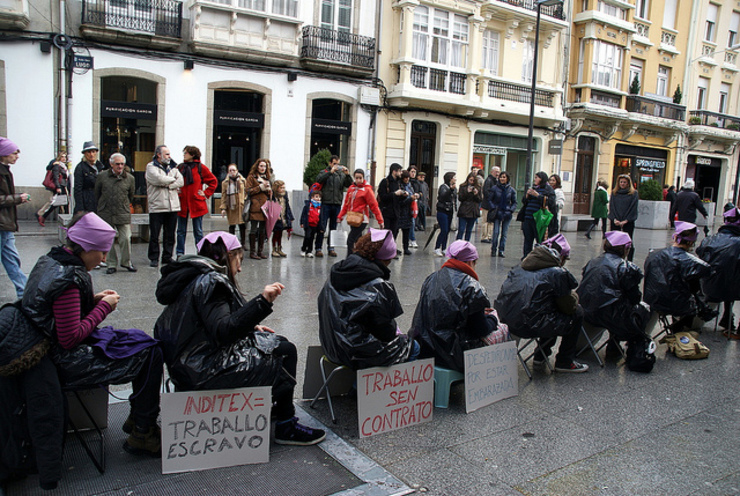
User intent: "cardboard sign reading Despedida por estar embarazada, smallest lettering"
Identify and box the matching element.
[465,341,519,413]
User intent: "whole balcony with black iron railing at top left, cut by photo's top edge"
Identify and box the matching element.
[80,0,182,50]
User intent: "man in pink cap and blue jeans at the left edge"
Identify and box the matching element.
[0,137,31,298]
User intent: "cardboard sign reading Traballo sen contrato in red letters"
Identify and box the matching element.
[357,358,434,437]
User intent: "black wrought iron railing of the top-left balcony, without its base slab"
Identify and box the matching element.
[82,0,182,38]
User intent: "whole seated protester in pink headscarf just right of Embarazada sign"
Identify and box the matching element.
[493,234,588,373]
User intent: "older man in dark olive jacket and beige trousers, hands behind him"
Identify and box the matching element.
[95,153,136,274]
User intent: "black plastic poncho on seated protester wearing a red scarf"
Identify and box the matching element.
[409,266,495,372]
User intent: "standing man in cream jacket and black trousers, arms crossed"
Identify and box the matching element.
[146,145,185,267]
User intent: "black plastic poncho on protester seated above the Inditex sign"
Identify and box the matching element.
[154,256,288,396]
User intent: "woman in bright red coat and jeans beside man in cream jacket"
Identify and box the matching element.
[175,146,218,257]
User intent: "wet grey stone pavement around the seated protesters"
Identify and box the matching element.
[0,218,740,496]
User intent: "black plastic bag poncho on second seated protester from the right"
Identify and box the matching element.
[645,246,710,317]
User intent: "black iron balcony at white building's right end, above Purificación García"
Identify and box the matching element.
[301,26,375,76]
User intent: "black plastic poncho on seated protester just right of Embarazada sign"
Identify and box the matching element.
[493,245,578,338]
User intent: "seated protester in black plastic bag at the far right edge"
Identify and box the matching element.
[696,205,740,339]
